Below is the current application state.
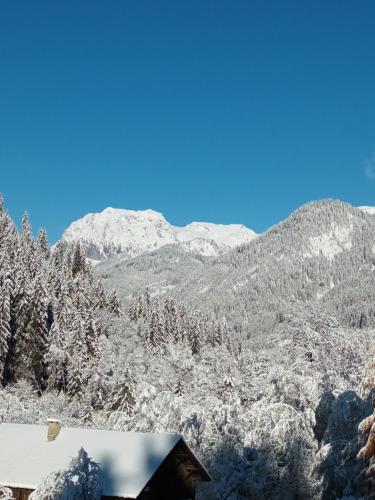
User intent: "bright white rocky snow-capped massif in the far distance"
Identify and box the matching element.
[62,208,256,261]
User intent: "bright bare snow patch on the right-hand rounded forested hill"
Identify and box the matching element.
[306,224,353,259]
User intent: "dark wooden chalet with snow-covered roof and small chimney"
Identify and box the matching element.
[0,421,210,500]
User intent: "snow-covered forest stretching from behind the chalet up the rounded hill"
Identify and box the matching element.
[0,200,375,500]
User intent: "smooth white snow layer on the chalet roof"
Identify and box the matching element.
[0,423,181,498]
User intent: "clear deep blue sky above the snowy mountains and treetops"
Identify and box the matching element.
[0,0,375,241]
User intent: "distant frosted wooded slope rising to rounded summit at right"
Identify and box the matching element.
[97,200,375,332]
